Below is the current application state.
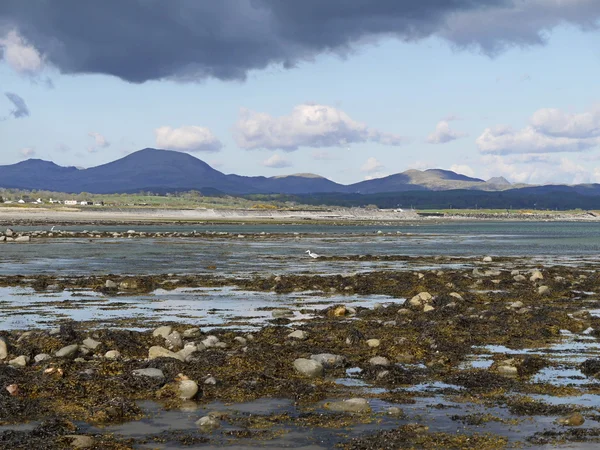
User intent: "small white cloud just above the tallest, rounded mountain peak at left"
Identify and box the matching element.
[154,126,223,153]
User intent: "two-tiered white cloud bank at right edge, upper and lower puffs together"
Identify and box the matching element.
[475,108,600,155]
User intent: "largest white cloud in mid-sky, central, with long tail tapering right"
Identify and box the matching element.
[234,104,407,151]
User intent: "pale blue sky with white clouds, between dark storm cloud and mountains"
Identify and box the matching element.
[0,0,600,183]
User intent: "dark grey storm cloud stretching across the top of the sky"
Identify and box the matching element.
[0,0,600,83]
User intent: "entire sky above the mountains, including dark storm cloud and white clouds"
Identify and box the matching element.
[0,0,600,184]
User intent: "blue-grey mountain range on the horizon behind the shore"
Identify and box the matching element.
[0,148,515,195]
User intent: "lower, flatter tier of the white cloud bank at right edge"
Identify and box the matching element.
[475,126,600,155]
